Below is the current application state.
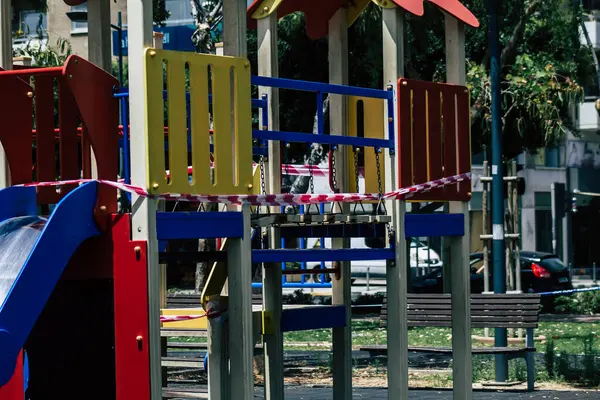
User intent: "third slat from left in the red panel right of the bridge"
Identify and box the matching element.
[427,88,444,180]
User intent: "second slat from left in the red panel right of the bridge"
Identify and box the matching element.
[412,88,428,182]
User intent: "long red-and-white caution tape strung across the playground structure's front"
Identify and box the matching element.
[19,173,471,206]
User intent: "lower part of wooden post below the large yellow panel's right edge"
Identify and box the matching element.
[227,203,254,400]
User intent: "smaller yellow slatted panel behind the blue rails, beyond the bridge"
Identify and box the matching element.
[348,96,385,193]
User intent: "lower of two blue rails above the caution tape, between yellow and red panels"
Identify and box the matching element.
[252,129,394,148]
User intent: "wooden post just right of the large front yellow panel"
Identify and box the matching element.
[257,12,284,400]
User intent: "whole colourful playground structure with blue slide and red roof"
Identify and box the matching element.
[0,0,477,400]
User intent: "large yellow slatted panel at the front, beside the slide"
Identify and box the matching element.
[145,49,252,195]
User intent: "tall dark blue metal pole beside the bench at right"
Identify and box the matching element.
[486,0,508,382]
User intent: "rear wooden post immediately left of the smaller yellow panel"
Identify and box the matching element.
[329,8,352,400]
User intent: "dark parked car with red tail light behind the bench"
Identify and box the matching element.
[411,251,573,293]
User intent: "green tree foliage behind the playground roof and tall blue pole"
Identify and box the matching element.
[249,0,594,158]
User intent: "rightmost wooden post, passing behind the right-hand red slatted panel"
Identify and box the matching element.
[445,14,473,400]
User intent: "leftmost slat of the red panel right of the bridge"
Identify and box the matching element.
[397,79,413,191]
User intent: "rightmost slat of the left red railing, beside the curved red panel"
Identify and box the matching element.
[58,78,79,196]
